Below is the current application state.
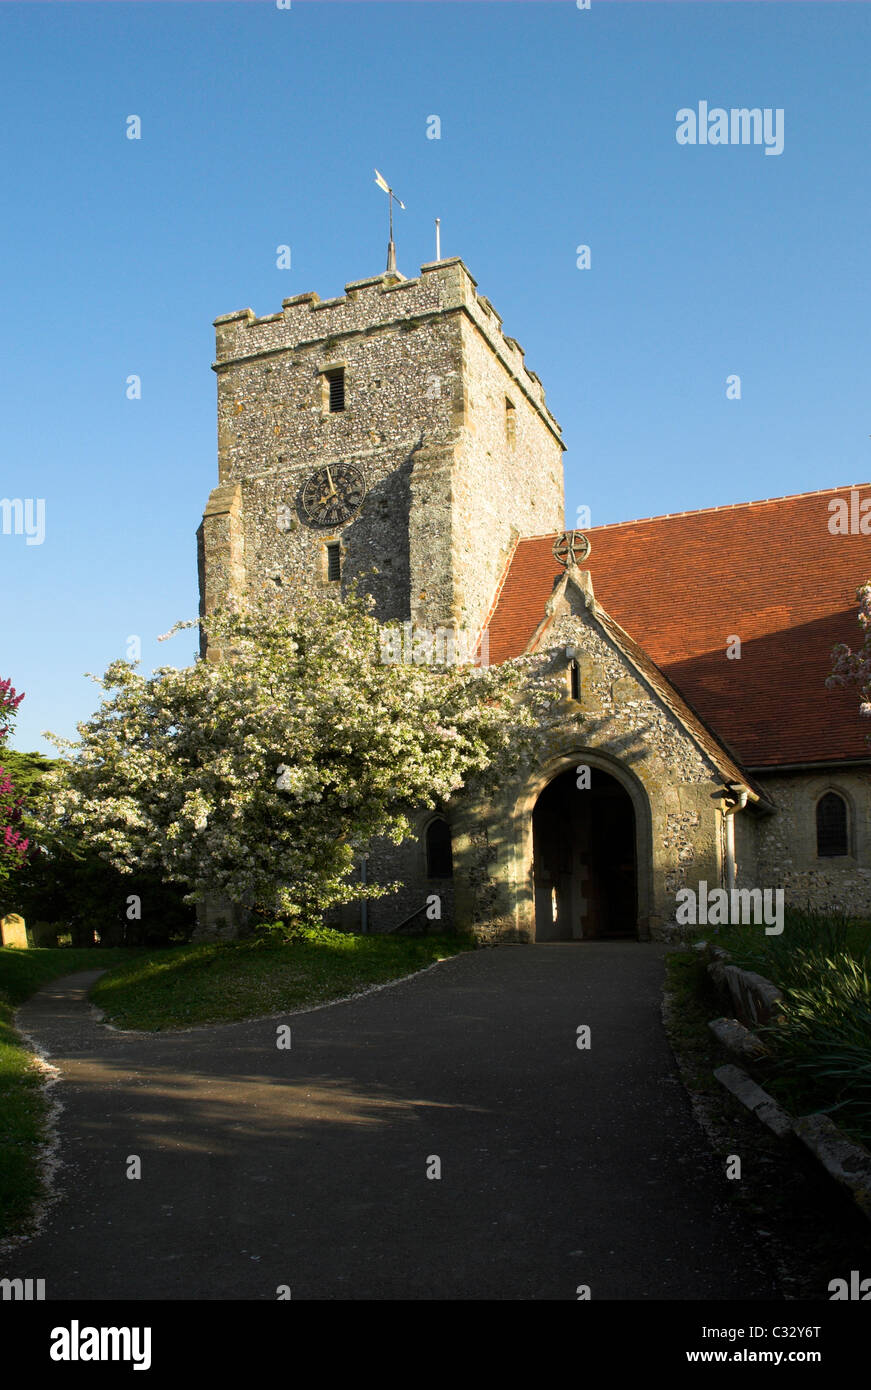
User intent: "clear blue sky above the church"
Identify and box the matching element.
[0,0,871,749]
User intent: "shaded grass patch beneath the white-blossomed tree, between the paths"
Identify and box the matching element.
[92,931,474,1030]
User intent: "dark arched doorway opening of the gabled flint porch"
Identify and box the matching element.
[532,767,638,941]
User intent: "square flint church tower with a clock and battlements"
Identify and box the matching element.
[199,259,564,647]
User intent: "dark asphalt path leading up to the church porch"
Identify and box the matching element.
[0,941,781,1301]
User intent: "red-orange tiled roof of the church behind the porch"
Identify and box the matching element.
[489,482,871,767]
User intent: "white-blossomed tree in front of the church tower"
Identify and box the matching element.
[35,591,556,923]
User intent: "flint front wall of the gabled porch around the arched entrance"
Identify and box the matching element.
[441,606,722,941]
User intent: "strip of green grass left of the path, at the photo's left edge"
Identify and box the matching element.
[0,947,129,1236]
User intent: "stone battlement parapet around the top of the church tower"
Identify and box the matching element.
[213,256,561,438]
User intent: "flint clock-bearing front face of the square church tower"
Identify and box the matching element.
[212,279,460,621]
